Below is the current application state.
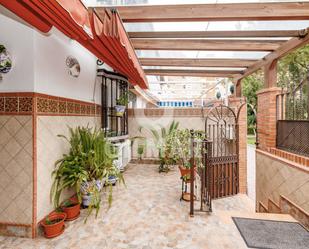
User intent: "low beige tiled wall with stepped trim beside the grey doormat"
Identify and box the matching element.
[256,150,309,227]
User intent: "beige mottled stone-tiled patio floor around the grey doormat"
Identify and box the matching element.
[0,165,293,249]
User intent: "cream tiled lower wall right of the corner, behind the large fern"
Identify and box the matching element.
[37,115,100,221]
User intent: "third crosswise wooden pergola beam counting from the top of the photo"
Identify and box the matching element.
[131,39,285,51]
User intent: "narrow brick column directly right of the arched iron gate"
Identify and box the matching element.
[229,97,247,194]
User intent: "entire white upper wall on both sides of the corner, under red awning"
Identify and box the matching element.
[0,7,110,103]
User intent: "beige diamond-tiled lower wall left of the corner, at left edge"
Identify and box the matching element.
[0,115,33,237]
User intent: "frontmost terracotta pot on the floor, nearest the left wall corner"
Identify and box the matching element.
[40,213,67,238]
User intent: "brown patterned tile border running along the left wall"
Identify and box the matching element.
[0,93,101,116]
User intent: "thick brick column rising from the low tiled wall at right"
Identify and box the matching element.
[257,87,282,152]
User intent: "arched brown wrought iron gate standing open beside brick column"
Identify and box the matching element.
[204,105,239,199]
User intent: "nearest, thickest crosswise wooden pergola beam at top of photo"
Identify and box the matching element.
[104,2,309,22]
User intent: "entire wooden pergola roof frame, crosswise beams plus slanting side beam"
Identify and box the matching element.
[92,2,309,88]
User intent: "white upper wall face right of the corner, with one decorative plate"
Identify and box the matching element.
[34,28,100,103]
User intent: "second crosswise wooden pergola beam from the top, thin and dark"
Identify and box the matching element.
[128,30,303,38]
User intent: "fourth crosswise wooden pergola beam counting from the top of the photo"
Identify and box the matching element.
[139,58,257,67]
